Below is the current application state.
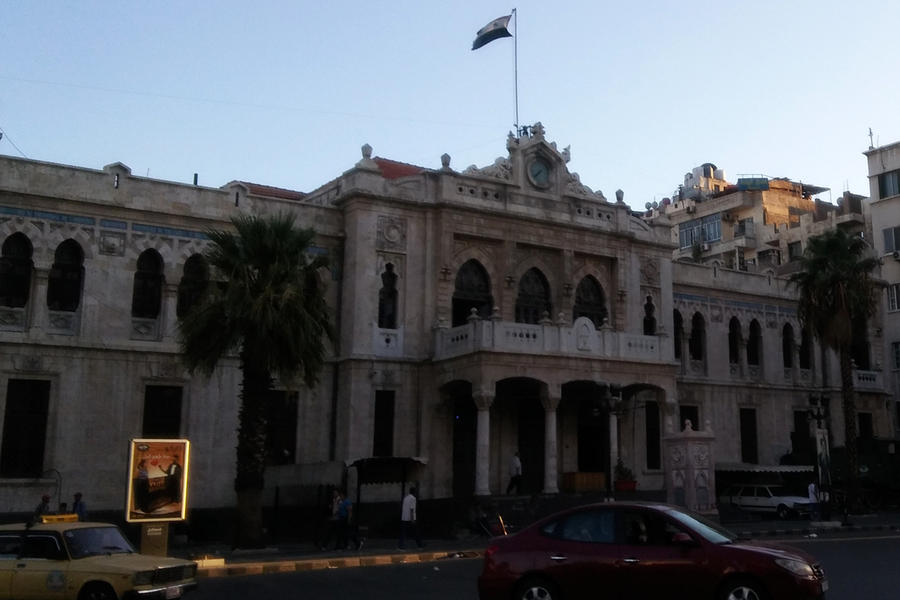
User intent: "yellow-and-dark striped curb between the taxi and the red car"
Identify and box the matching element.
[197,549,484,579]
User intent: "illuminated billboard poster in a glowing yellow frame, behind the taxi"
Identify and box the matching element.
[125,439,191,523]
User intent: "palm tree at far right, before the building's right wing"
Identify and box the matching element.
[791,228,880,507]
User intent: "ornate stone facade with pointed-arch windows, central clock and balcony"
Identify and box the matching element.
[0,124,885,512]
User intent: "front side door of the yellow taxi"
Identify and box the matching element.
[11,531,69,600]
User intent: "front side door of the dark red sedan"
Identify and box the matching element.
[617,508,716,600]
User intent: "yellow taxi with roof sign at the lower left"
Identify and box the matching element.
[0,515,197,600]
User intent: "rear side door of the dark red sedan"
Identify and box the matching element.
[534,507,621,600]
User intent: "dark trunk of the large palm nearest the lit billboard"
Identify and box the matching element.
[234,352,272,548]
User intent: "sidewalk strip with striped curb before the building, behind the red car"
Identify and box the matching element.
[178,511,900,578]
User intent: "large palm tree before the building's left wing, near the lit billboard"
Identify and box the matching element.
[179,215,334,547]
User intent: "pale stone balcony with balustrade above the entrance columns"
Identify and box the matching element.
[434,317,671,362]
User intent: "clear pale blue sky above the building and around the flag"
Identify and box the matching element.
[0,0,900,208]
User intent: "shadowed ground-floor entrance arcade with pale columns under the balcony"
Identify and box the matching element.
[441,377,665,497]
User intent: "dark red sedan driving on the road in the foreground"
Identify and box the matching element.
[478,502,828,600]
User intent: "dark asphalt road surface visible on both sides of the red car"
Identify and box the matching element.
[187,535,900,600]
